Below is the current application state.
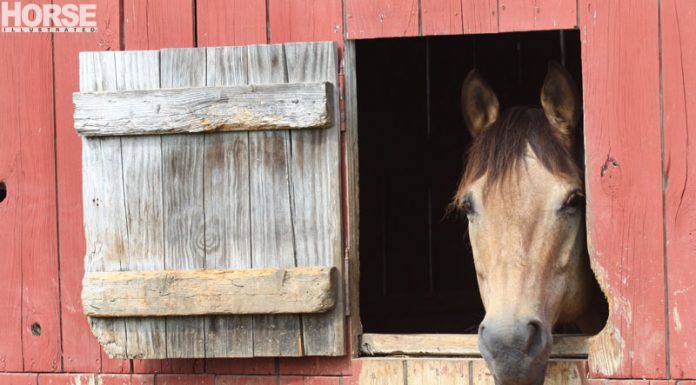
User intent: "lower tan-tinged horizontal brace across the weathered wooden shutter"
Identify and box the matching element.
[82,267,339,317]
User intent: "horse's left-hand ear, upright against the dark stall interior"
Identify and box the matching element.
[461,69,499,137]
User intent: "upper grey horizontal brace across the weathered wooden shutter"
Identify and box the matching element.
[73,82,333,136]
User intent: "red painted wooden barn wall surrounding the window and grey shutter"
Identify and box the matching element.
[0,0,696,385]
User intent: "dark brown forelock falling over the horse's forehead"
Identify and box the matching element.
[453,107,580,206]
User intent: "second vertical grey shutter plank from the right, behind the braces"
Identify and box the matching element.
[248,45,302,357]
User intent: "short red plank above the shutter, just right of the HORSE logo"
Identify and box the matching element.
[123,0,195,50]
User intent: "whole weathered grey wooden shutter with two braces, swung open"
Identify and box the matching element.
[74,43,345,358]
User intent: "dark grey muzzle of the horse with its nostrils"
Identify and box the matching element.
[479,318,552,385]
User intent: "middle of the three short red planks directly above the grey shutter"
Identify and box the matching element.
[196,0,267,47]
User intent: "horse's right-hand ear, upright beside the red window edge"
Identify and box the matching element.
[541,61,580,144]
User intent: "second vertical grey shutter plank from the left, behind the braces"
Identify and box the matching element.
[115,51,166,358]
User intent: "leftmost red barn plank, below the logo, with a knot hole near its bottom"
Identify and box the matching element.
[0,4,62,372]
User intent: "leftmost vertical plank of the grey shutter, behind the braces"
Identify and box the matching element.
[80,52,128,357]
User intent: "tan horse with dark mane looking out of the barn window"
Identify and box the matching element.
[452,62,606,385]
